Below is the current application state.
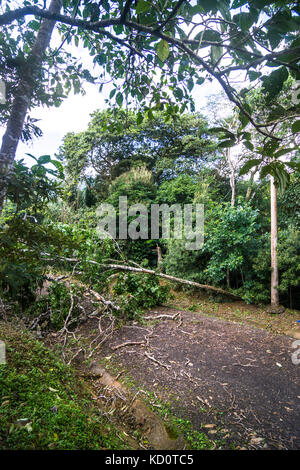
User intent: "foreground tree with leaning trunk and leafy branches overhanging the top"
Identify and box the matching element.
[0,0,300,210]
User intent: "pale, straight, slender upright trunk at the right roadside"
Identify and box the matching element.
[270,176,279,306]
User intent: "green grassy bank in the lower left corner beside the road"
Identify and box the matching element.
[0,323,125,449]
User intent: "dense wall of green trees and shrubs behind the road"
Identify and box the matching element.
[1,105,300,310]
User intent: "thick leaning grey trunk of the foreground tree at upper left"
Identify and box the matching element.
[0,0,62,214]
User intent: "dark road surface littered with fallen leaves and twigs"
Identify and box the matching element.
[97,308,300,449]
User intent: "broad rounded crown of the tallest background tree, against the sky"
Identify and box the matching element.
[60,108,216,193]
